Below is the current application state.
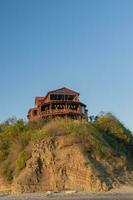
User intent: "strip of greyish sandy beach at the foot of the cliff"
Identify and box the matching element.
[0,186,133,200]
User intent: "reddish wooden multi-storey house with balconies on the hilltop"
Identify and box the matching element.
[27,87,88,121]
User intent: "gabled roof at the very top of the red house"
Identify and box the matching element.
[46,87,80,96]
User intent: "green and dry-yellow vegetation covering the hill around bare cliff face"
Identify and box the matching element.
[0,114,133,182]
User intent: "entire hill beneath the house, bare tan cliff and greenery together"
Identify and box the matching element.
[0,114,133,193]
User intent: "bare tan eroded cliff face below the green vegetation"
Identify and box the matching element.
[12,135,133,193]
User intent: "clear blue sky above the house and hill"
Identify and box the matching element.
[0,0,133,130]
